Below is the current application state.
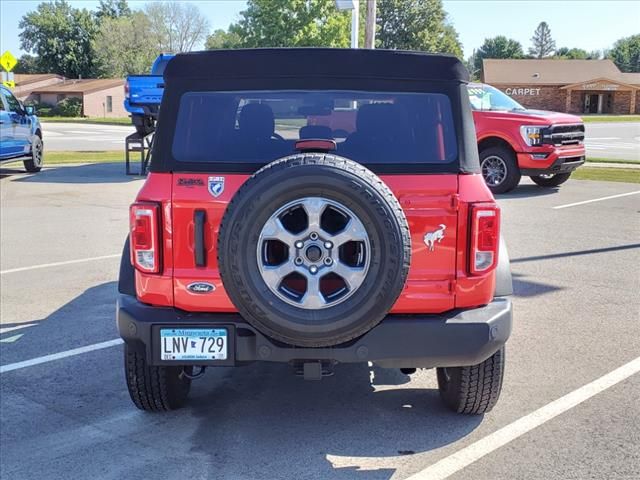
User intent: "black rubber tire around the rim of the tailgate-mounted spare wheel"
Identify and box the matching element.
[218,157,408,346]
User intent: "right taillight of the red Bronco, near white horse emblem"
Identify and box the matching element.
[469,203,500,275]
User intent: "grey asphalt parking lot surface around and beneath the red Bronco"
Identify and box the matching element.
[0,164,640,480]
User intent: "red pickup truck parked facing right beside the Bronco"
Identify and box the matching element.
[468,83,585,193]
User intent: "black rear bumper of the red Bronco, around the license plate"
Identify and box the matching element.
[116,295,512,368]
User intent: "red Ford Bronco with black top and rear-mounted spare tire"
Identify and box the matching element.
[117,49,512,414]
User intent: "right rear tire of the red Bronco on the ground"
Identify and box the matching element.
[437,347,504,415]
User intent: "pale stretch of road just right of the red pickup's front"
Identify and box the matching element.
[585,122,640,162]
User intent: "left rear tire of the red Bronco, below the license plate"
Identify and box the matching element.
[124,344,192,412]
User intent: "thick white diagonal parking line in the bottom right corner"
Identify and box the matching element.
[407,357,640,480]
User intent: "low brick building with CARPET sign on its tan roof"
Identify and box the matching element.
[482,59,640,115]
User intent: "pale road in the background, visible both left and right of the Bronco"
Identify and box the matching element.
[43,122,640,162]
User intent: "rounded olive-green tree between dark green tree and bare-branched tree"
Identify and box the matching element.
[94,12,161,78]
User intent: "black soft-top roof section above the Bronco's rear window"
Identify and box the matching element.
[164,48,469,86]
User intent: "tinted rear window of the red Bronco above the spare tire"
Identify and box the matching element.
[172,90,458,164]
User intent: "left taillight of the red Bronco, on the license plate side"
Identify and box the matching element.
[129,202,160,273]
